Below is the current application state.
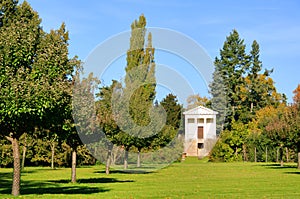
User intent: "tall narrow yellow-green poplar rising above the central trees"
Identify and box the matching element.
[125,15,156,126]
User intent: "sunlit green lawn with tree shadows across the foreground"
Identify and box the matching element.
[0,158,300,199]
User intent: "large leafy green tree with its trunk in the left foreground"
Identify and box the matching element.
[0,0,76,195]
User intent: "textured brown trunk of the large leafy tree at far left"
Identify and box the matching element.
[6,137,21,196]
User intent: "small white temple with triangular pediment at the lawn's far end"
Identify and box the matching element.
[183,106,218,158]
